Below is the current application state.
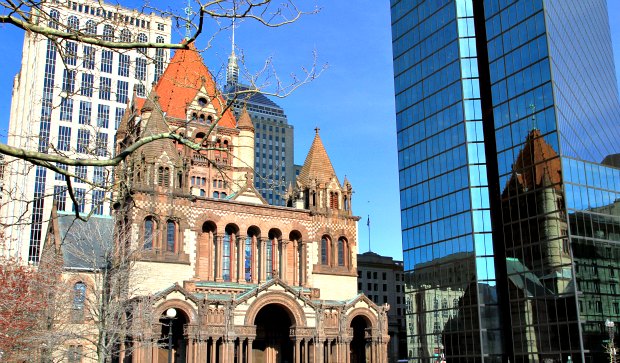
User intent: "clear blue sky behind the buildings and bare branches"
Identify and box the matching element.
[0,0,620,259]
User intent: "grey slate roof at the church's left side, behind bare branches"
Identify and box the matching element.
[58,213,114,270]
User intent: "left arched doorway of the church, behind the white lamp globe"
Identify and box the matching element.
[157,309,189,363]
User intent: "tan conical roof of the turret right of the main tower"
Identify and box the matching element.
[297,128,340,186]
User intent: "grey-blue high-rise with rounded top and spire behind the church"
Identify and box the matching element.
[224,43,296,205]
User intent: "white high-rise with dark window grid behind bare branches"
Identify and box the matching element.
[2,0,171,262]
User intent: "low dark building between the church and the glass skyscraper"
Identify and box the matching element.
[357,251,407,363]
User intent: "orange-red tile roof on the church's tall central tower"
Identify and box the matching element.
[156,44,236,128]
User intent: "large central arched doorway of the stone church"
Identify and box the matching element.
[252,304,294,363]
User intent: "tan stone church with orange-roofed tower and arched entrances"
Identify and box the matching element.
[44,44,389,363]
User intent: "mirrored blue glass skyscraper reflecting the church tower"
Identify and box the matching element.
[390,0,620,362]
